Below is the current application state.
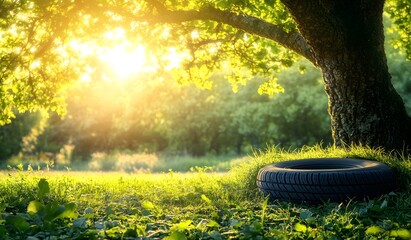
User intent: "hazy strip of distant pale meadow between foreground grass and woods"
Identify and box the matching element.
[0,152,250,173]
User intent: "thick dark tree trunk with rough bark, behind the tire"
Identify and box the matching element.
[284,0,411,150]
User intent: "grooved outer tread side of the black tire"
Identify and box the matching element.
[257,159,395,202]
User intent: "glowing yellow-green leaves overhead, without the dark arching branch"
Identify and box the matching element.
[0,0,410,125]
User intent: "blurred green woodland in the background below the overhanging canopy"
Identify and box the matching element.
[0,18,411,170]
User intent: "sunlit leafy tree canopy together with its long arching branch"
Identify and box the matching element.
[0,0,411,150]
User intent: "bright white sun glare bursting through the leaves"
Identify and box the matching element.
[70,29,189,83]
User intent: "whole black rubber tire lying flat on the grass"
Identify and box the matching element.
[257,158,396,202]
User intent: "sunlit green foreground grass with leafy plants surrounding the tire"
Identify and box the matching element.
[0,147,411,240]
